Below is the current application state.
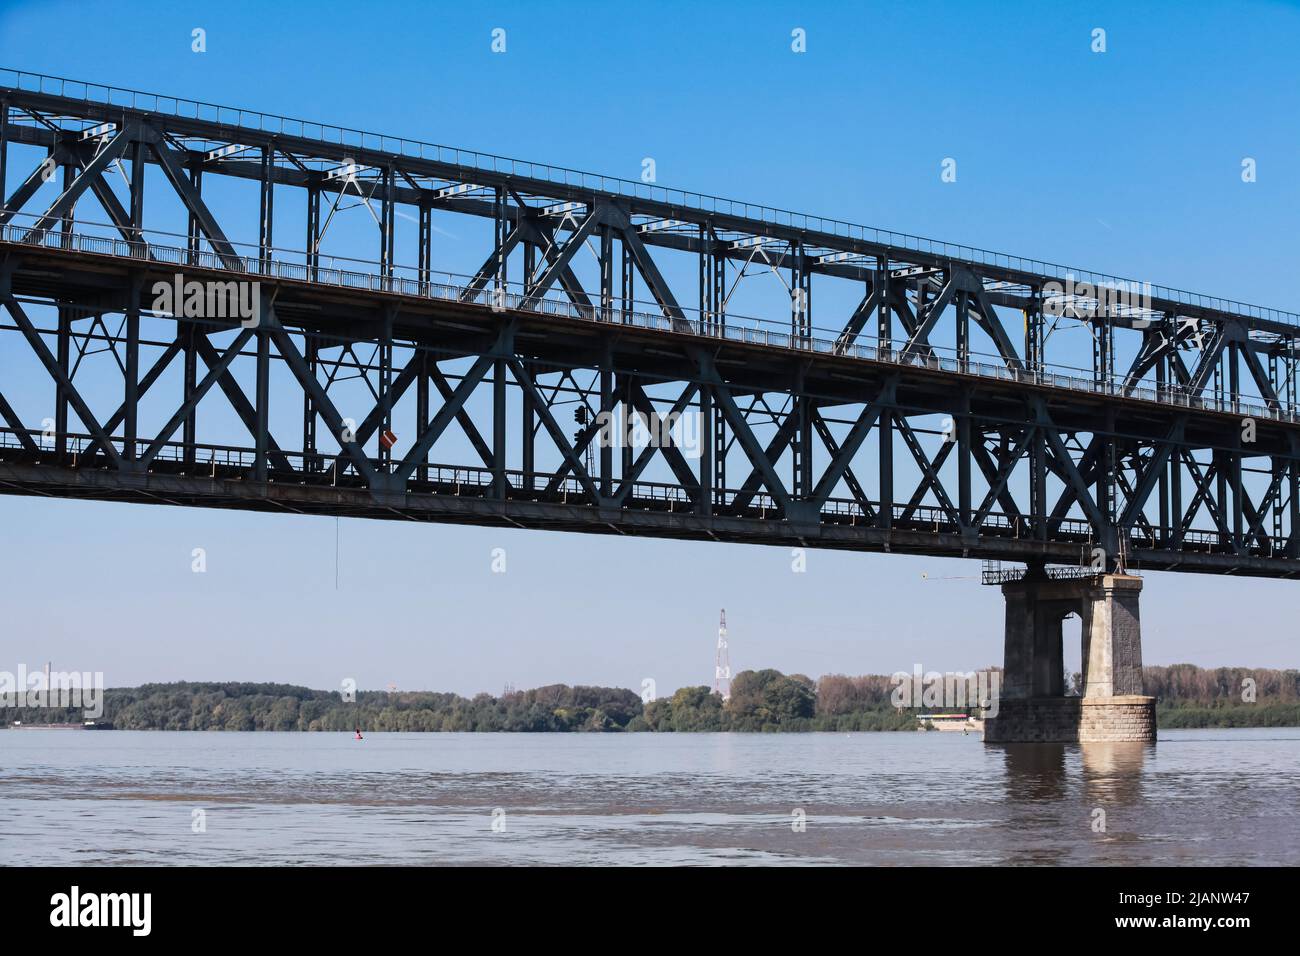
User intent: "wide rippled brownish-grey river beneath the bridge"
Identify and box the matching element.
[0,728,1300,866]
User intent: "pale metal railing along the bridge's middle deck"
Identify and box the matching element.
[0,217,1300,421]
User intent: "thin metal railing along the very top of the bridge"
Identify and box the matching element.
[0,68,1300,326]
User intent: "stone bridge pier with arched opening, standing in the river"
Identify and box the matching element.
[984,570,1156,743]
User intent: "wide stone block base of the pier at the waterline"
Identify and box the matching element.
[984,695,1156,744]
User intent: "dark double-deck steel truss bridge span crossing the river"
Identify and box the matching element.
[0,70,1300,576]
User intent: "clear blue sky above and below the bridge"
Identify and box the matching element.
[0,0,1300,693]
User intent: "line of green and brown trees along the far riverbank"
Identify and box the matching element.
[0,665,1300,732]
